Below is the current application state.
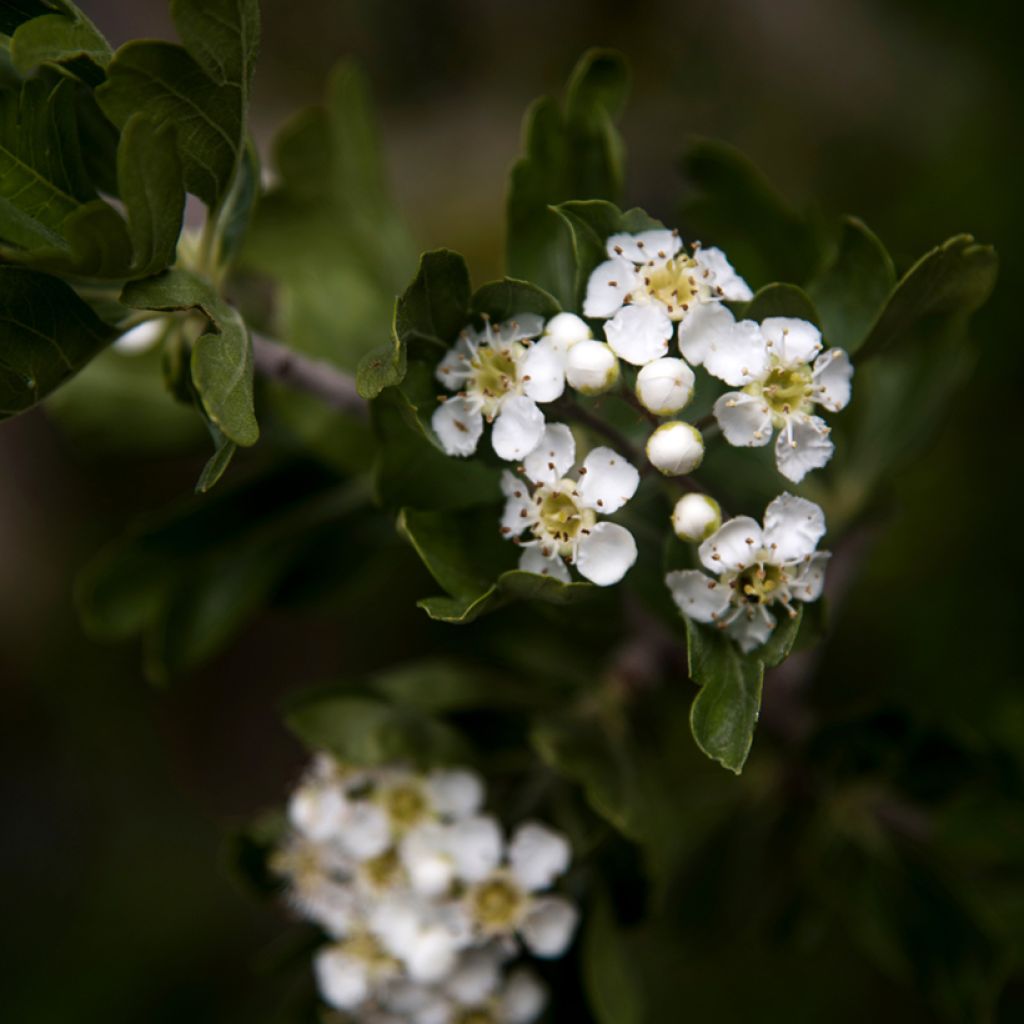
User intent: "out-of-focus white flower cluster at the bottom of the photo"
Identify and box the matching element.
[272,755,579,1024]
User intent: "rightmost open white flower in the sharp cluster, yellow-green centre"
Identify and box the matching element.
[706,316,853,483]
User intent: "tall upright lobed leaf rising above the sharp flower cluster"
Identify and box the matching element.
[506,50,629,309]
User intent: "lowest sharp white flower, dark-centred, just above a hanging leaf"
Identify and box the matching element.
[666,494,830,651]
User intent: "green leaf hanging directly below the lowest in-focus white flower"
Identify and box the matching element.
[686,618,764,775]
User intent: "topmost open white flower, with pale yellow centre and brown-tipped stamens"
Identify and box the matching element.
[583,229,752,366]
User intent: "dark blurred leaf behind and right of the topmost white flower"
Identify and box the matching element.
[682,139,820,288]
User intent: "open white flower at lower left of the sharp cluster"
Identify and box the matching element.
[501,423,640,587]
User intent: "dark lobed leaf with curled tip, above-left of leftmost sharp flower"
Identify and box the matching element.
[355,249,470,398]
